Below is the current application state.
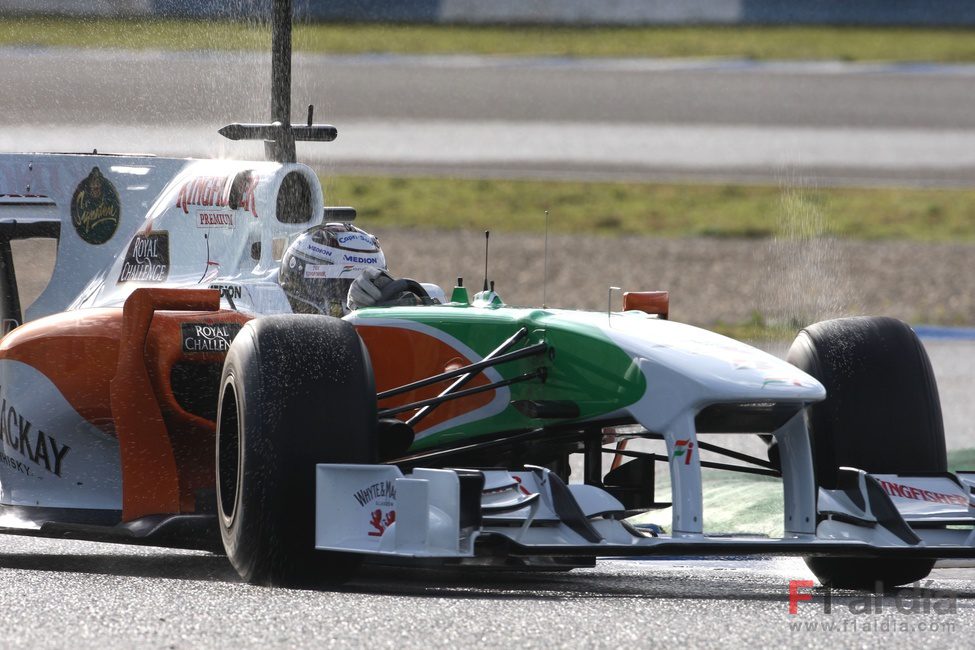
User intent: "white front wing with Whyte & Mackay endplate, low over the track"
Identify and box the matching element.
[315,464,975,564]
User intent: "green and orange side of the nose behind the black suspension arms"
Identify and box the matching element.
[351,305,646,450]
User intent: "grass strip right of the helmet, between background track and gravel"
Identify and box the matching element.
[322,176,975,242]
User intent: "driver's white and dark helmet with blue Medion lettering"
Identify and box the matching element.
[278,223,386,317]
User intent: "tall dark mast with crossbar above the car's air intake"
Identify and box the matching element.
[218,0,338,163]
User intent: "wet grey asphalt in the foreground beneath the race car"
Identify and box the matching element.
[0,537,975,648]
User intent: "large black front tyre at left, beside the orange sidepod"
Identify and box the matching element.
[216,315,376,586]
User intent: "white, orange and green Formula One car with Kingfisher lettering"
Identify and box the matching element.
[0,2,975,587]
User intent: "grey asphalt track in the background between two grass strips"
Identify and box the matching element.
[0,49,975,186]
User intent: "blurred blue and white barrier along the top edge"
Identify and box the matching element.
[0,0,975,26]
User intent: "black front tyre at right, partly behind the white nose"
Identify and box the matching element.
[787,318,947,589]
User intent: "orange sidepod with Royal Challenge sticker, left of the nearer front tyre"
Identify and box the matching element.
[0,289,250,520]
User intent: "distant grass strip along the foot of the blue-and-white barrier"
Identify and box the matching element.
[0,16,975,63]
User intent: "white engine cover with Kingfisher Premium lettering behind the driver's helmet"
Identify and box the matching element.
[0,153,324,321]
